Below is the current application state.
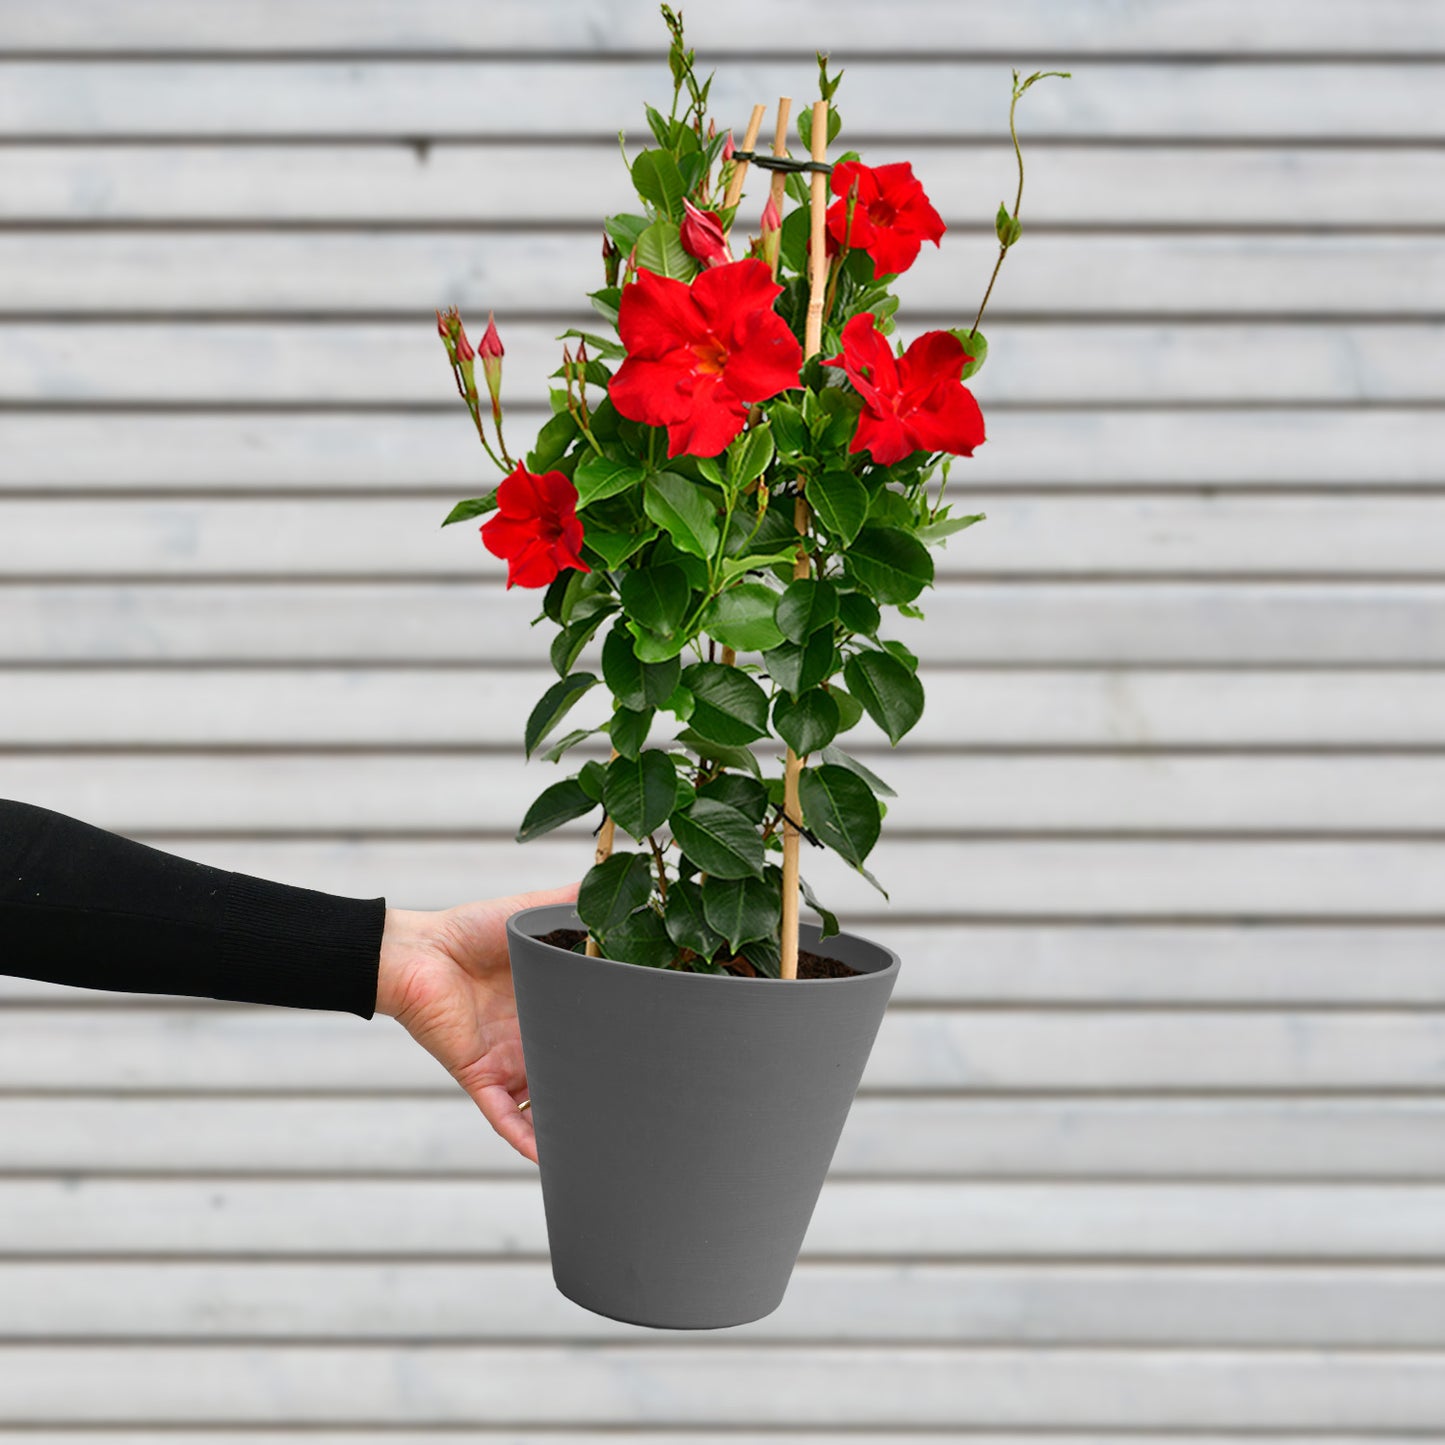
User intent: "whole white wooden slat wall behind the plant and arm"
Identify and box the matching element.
[0,0,1445,1445]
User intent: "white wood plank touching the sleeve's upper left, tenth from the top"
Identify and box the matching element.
[11,745,1445,838]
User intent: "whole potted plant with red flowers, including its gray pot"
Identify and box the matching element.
[438,6,1063,1328]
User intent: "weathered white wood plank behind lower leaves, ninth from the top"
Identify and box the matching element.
[8,663,1445,751]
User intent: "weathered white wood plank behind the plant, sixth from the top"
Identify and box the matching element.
[0,410,1445,488]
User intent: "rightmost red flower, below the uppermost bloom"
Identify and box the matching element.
[824,311,984,467]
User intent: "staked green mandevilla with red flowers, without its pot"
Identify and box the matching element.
[438,6,1056,978]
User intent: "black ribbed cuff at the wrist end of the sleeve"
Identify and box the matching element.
[215,873,386,1019]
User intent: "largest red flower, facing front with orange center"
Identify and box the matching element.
[608,257,803,457]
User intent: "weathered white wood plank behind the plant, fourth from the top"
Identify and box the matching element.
[0,232,1445,317]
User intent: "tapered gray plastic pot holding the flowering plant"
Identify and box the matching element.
[507,905,899,1329]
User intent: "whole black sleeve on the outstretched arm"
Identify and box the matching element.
[0,799,386,1019]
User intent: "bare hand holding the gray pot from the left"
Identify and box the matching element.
[376,883,577,1163]
